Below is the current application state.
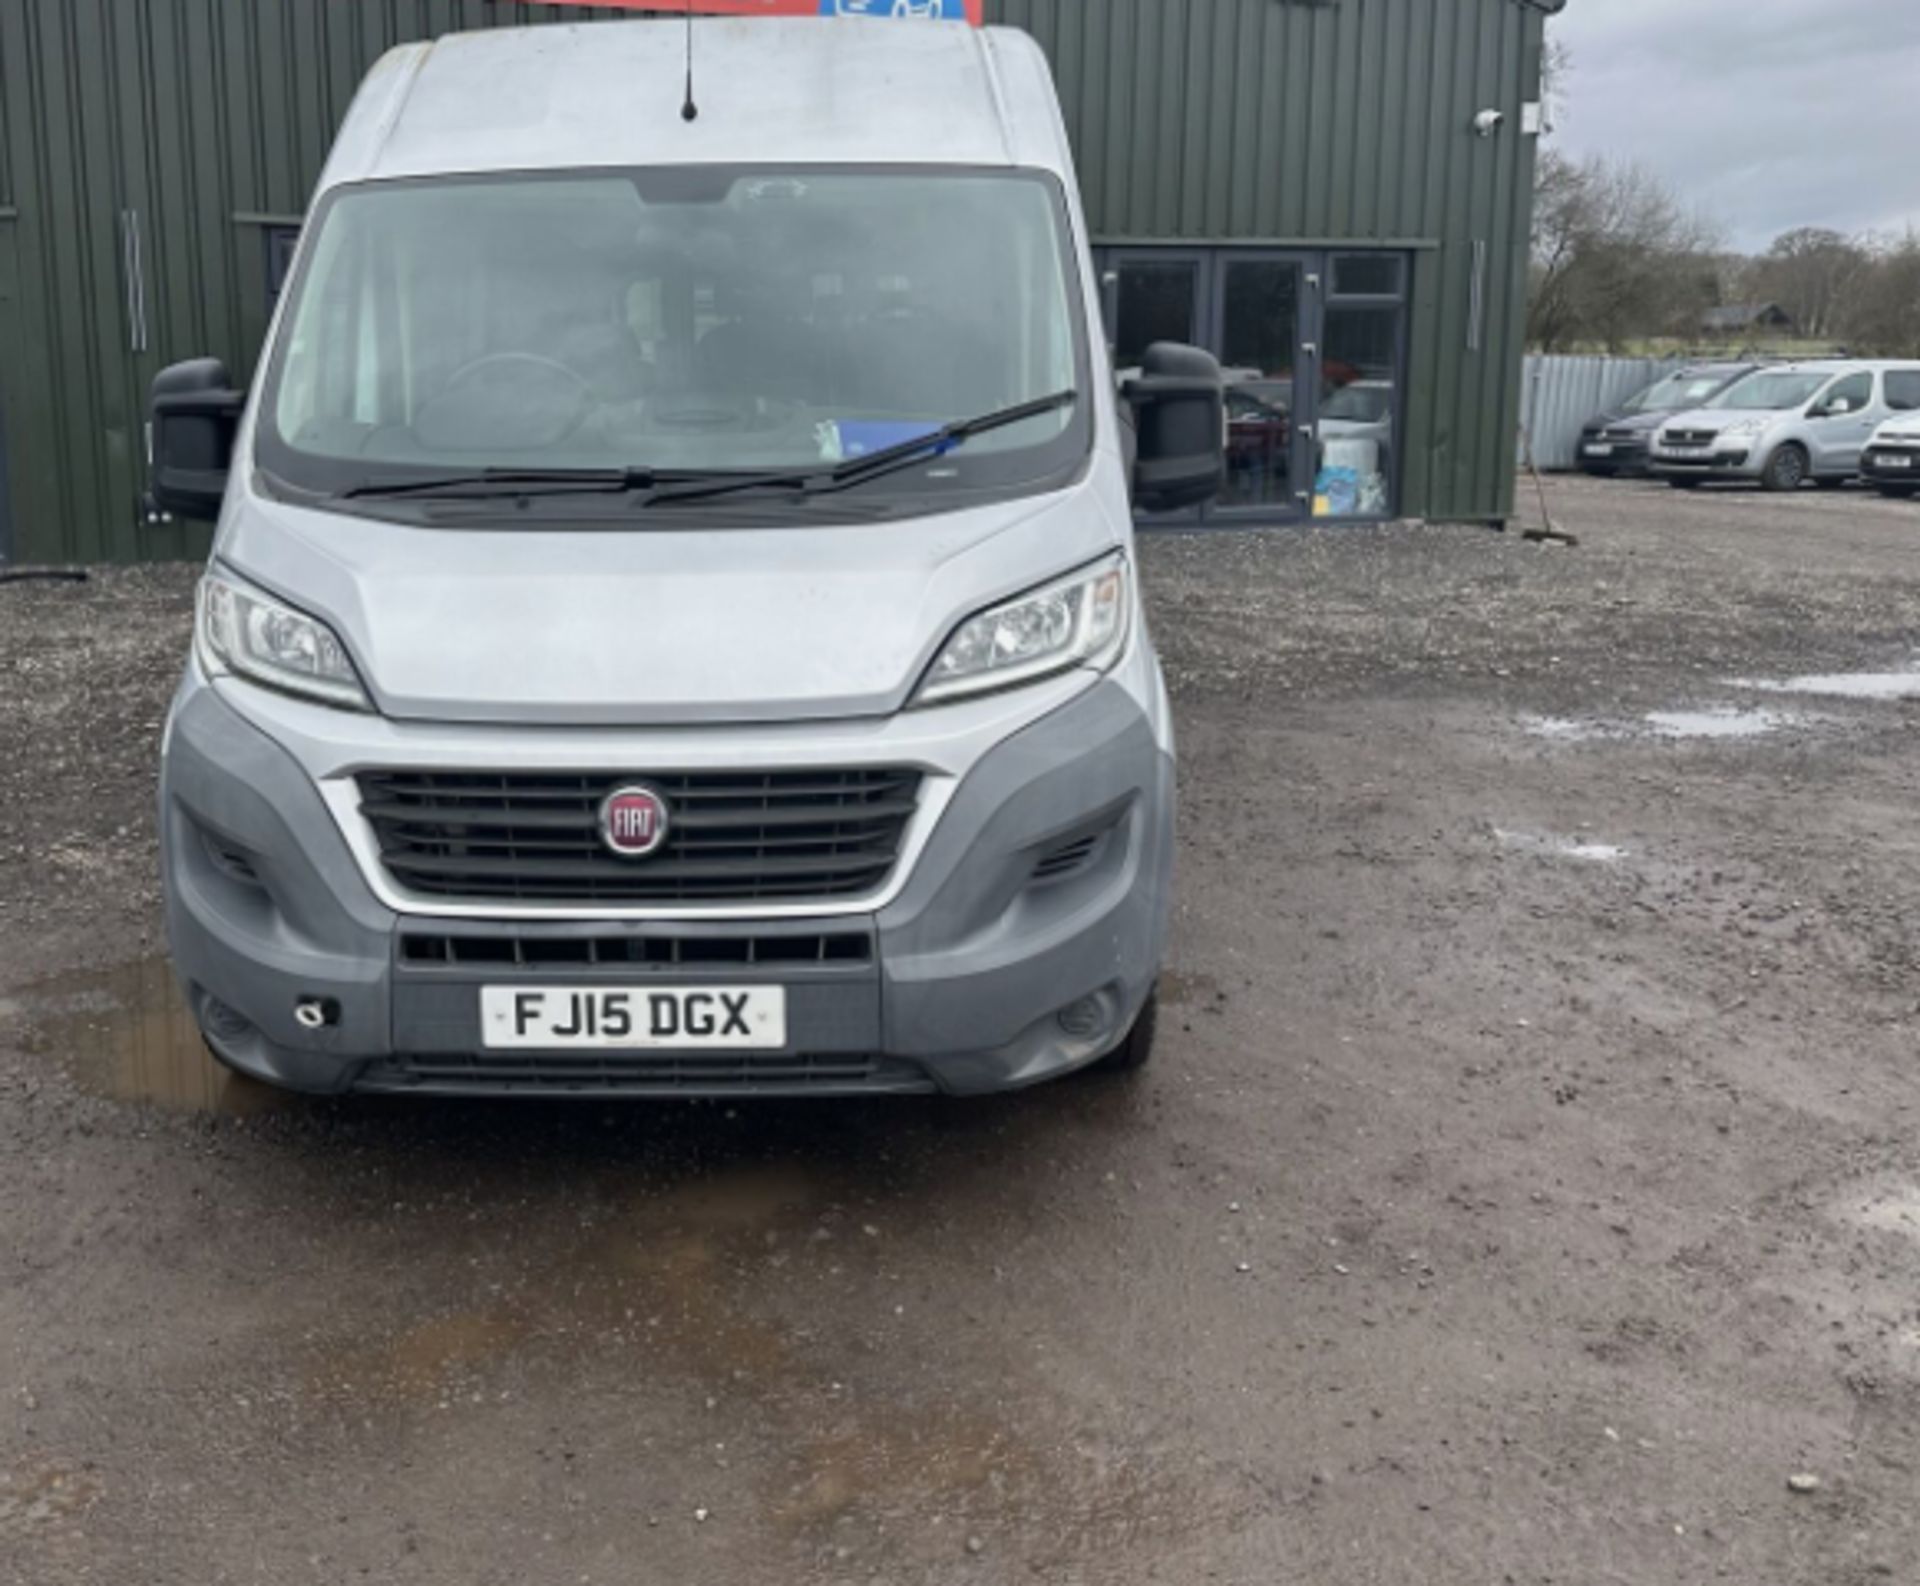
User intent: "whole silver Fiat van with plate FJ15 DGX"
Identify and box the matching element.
[152,19,1225,1096]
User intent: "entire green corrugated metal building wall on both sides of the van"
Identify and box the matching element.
[0,0,1542,563]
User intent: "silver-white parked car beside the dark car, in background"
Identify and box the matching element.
[1653,359,1920,490]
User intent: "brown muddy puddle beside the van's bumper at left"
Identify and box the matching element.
[0,958,286,1117]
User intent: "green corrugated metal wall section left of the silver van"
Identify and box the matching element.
[0,0,616,563]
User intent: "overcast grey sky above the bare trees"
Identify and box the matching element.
[1551,0,1920,252]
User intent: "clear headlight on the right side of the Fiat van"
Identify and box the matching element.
[914,555,1133,705]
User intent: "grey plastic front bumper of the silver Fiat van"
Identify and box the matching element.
[161,651,1173,1096]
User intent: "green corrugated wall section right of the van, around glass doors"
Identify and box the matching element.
[987,0,1544,518]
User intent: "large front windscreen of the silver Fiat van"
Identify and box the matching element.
[259,169,1091,495]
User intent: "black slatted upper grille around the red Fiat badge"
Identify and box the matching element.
[359,768,922,904]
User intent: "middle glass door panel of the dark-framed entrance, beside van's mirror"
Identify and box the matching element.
[1204,252,1319,522]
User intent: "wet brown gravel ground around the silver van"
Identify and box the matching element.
[0,472,1920,1586]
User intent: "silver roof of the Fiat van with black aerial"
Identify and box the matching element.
[321,17,1071,192]
